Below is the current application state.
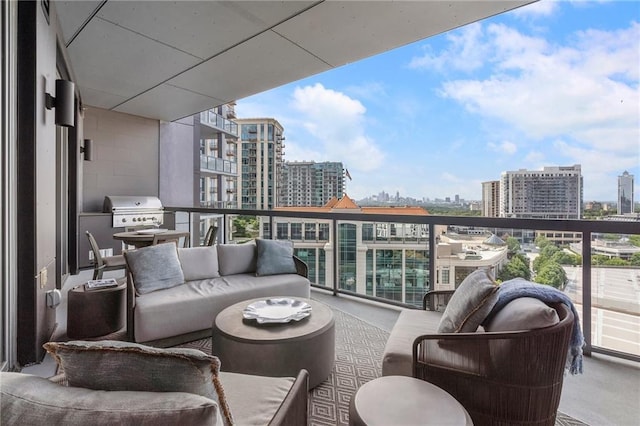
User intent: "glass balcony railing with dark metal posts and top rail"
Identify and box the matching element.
[166,207,640,361]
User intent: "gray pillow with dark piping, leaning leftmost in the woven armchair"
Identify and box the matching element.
[438,269,498,333]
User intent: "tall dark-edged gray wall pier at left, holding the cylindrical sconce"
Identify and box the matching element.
[16,2,57,365]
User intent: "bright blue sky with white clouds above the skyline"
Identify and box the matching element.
[236,0,640,202]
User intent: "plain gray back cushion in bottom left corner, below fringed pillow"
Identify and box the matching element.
[0,372,222,426]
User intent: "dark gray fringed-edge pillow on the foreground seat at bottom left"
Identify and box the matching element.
[43,340,233,424]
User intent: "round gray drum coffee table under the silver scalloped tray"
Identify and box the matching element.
[212,297,335,388]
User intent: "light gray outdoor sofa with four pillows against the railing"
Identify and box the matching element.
[125,239,310,346]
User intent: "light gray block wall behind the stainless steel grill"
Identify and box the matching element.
[82,107,160,212]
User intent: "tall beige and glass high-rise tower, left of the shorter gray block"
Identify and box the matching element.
[236,118,284,210]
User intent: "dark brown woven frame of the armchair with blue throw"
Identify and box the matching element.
[413,302,574,426]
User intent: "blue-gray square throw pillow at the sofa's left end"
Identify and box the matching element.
[124,243,184,294]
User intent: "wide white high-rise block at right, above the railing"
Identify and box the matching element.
[500,164,583,219]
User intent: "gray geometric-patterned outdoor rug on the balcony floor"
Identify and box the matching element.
[179,308,585,426]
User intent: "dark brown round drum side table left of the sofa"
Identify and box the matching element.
[67,282,127,339]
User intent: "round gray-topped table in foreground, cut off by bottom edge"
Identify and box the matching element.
[349,376,473,426]
